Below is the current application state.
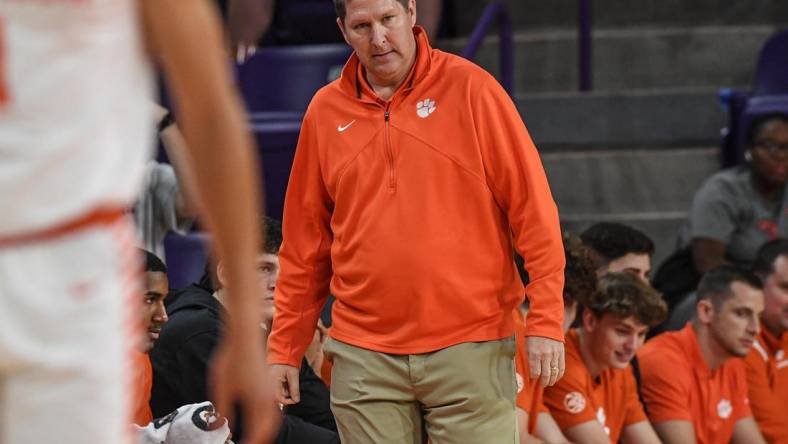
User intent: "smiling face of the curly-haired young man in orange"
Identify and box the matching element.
[583,310,648,368]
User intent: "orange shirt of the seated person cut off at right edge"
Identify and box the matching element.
[744,324,788,444]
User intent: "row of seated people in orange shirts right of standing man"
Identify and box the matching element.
[518,224,788,443]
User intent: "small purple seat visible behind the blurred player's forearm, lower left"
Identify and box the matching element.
[164,233,210,289]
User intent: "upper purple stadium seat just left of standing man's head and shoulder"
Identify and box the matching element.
[237,44,352,113]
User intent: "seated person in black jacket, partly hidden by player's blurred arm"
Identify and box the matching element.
[151,218,339,444]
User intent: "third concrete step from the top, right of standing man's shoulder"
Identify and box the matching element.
[515,88,727,151]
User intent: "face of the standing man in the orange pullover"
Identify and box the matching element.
[337,0,416,85]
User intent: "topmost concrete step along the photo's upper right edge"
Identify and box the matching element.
[445,0,788,35]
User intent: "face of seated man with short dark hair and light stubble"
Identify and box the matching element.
[709,281,763,357]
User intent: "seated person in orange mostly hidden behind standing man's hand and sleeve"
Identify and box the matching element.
[514,235,597,444]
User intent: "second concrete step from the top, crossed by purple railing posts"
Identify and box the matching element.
[438,25,788,94]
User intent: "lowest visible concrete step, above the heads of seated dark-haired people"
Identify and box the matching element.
[542,146,719,264]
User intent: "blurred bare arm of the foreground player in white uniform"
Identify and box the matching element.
[140,0,277,443]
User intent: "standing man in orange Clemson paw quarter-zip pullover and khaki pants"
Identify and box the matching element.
[269,0,564,444]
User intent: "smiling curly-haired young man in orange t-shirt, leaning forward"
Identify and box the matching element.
[544,272,667,443]
